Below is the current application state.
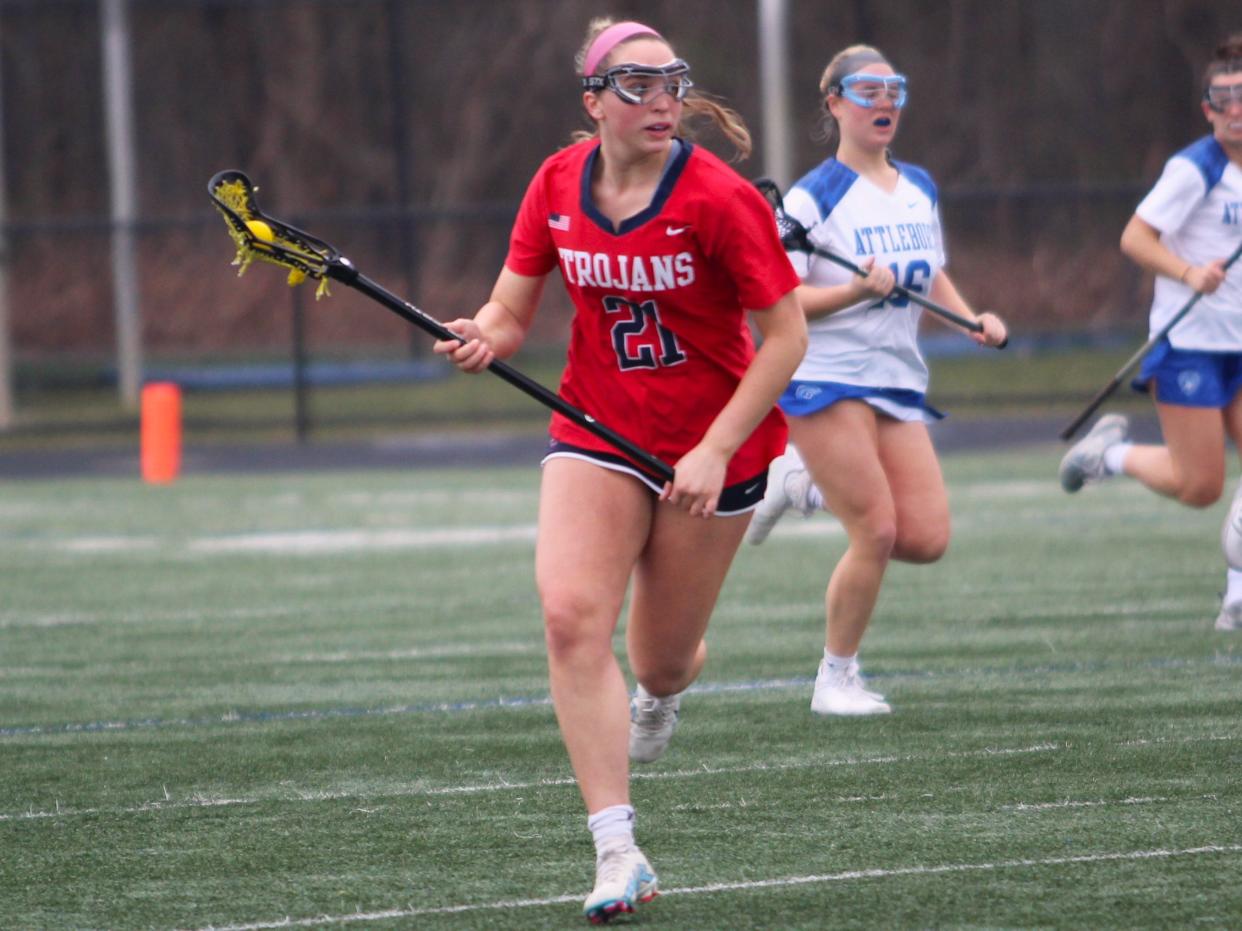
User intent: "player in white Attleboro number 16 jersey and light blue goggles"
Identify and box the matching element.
[748,46,1006,715]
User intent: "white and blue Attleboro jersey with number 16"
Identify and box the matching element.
[785,159,945,391]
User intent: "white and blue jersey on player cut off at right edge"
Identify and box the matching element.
[1134,135,1242,353]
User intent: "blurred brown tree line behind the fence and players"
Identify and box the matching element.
[0,0,1242,372]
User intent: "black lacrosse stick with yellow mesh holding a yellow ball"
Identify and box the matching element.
[207,171,673,483]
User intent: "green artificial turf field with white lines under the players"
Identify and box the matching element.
[0,446,1242,929]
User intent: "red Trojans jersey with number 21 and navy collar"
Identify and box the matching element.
[505,140,799,485]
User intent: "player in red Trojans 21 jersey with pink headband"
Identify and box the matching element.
[436,20,806,922]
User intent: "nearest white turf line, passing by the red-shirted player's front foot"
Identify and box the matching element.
[186,844,1242,931]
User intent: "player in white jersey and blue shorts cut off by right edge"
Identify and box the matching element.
[1061,34,1242,631]
